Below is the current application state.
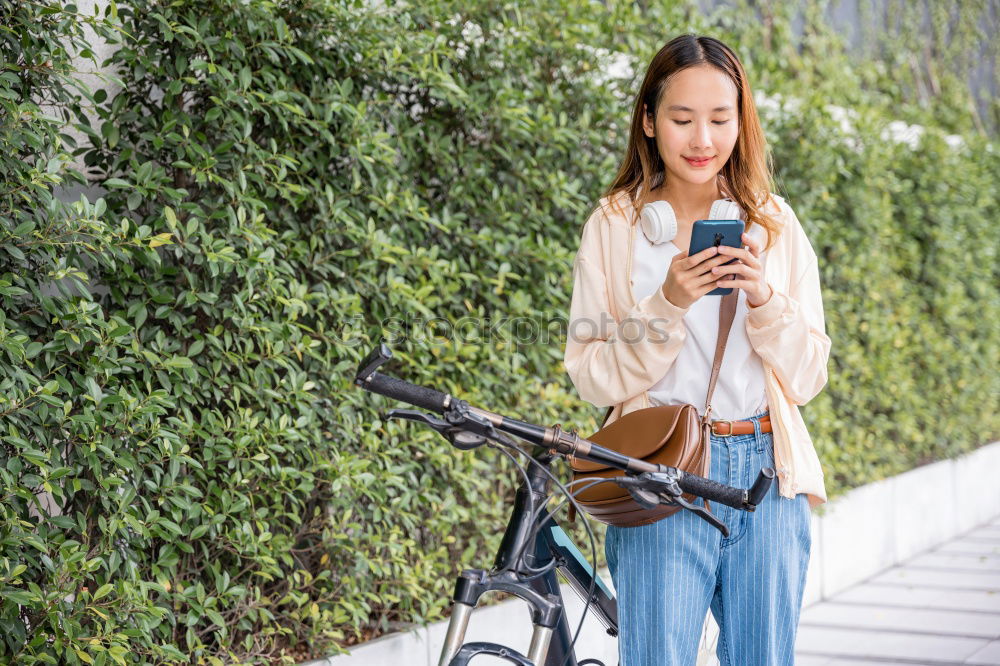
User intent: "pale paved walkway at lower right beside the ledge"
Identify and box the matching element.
[795,512,1000,666]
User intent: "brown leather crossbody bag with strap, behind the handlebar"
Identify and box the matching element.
[569,289,739,527]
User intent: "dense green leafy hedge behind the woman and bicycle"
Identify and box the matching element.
[0,0,1000,664]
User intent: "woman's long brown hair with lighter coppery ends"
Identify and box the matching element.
[604,34,781,249]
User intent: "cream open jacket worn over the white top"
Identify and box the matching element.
[563,193,830,507]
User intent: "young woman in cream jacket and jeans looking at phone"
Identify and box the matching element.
[565,35,830,666]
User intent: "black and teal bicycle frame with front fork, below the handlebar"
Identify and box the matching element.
[438,447,618,666]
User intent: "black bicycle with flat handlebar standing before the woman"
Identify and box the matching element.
[354,341,774,666]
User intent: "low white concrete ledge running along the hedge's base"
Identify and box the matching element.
[307,442,1000,666]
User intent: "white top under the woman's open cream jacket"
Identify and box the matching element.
[632,224,767,421]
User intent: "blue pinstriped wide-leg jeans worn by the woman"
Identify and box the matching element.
[605,411,811,666]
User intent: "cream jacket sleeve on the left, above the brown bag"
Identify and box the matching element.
[563,208,688,407]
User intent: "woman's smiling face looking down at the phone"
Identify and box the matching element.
[643,65,740,185]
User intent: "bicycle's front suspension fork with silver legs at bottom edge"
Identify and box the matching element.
[438,569,562,666]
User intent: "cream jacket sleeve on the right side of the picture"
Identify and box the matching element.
[746,220,830,405]
